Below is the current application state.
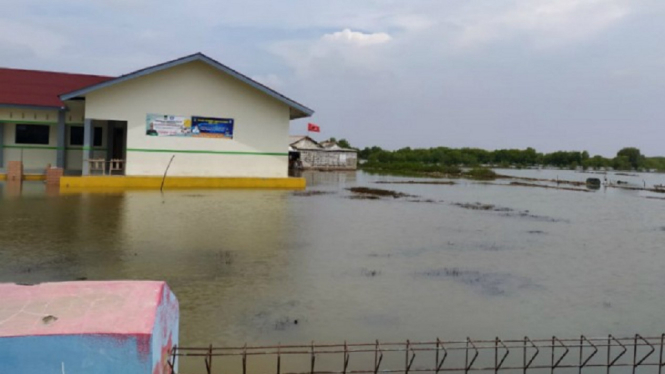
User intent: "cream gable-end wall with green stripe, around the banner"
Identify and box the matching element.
[85,61,289,177]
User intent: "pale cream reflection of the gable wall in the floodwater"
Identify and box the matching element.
[115,190,295,345]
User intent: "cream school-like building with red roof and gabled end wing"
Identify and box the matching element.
[0,53,313,187]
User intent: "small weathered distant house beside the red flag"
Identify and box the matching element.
[289,135,358,170]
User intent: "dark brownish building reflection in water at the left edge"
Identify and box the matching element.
[0,187,123,283]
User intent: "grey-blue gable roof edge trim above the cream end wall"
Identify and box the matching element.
[60,52,314,119]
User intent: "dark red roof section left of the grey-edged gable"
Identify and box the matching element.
[0,68,114,107]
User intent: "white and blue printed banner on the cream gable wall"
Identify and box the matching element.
[145,114,233,139]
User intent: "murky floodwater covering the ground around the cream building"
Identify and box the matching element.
[0,170,665,372]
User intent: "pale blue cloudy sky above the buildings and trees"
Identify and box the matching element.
[0,0,665,156]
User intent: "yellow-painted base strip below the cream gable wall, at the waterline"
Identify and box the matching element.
[60,176,306,190]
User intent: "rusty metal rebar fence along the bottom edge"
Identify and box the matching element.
[169,334,665,374]
